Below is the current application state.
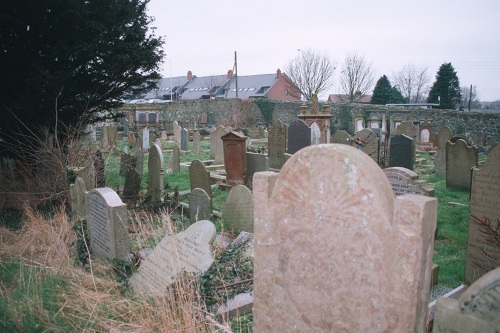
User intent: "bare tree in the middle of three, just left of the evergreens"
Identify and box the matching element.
[340,52,375,103]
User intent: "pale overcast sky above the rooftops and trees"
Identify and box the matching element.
[148,0,500,101]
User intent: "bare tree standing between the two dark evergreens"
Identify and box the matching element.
[392,64,430,103]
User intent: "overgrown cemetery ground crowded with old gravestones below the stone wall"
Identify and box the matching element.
[0,103,500,332]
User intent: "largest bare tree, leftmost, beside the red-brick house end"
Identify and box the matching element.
[283,49,335,101]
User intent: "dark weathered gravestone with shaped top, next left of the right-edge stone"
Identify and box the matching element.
[445,139,478,190]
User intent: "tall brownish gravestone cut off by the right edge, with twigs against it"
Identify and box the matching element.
[465,146,500,284]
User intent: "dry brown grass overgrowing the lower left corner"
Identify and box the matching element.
[0,209,234,332]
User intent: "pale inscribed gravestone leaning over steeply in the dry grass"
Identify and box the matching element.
[128,220,215,296]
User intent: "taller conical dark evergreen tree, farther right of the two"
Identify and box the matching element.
[427,63,462,110]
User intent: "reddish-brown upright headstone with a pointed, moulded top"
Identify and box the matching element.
[221,132,247,186]
